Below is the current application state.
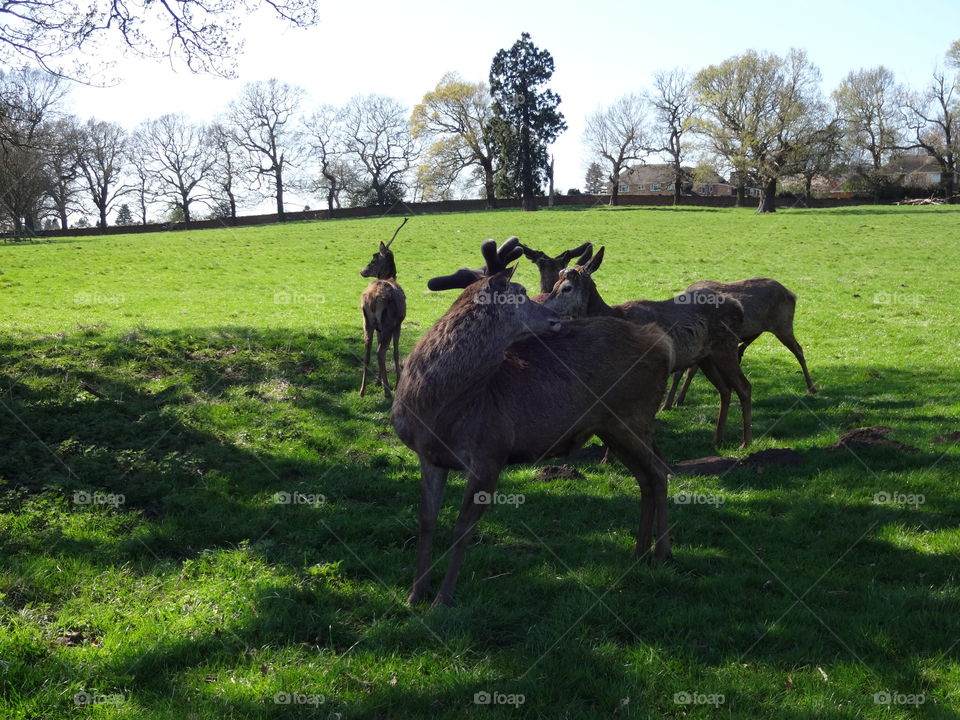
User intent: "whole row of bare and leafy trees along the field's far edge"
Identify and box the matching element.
[0,33,960,234]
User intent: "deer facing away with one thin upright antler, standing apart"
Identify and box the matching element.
[360,218,409,400]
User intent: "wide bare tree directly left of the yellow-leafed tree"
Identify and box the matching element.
[344,95,420,205]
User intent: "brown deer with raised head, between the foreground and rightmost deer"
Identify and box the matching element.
[544,248,751,448]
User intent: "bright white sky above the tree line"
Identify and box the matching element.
[65,0,960,202]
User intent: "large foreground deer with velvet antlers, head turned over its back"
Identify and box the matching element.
[391,238,673,606]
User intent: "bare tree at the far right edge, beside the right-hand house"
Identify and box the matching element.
[903,69,960,197]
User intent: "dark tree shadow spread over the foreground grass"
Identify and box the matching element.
[0,330,960,718]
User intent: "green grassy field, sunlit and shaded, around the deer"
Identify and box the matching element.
[0,207,960,720]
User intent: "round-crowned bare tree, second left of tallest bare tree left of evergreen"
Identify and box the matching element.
[143,114,213,223]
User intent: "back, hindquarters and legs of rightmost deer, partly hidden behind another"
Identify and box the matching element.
[663,278,817,410]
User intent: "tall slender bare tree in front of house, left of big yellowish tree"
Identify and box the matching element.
[646,69,699,205]
